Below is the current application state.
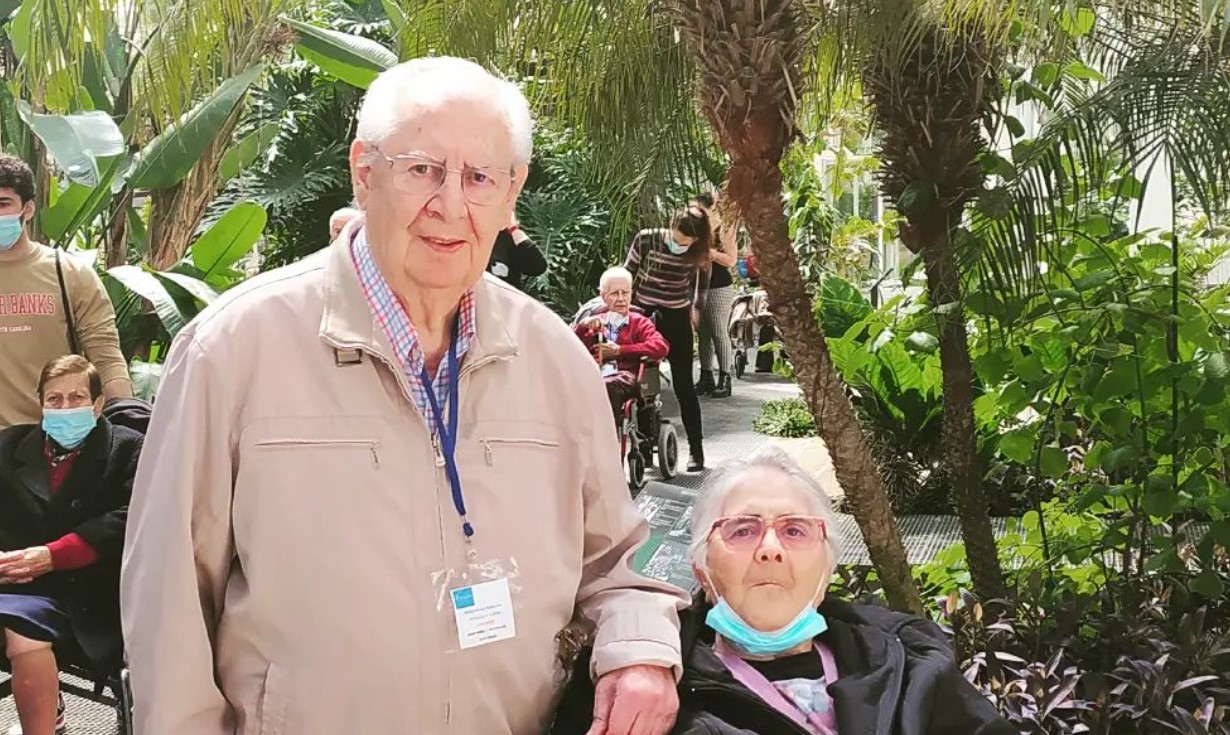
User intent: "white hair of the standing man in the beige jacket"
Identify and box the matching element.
[355,57,534,165]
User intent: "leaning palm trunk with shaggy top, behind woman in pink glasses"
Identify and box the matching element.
[675,0,923,613]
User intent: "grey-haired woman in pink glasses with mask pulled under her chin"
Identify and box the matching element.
[552,447,1017,735]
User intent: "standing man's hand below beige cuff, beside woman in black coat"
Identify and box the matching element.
[585,665,679,735]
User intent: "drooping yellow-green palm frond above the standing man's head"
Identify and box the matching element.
[389,0,720,224]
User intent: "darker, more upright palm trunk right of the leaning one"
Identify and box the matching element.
[863,18,1005,600]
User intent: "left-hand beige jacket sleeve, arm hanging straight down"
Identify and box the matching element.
[121,329,237,735]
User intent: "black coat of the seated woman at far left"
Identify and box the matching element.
[0,418,143,671]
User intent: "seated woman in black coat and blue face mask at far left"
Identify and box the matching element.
[0,355,143,735]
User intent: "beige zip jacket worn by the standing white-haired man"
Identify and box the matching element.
[122,237,686,735]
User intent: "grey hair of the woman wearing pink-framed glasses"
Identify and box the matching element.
[689,445,841,570]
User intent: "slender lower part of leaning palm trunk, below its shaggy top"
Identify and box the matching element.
[728,161,924,615]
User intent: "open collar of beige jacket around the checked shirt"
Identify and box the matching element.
[320,225,518,372]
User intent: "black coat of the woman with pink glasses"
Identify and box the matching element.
[550,600,1020,735]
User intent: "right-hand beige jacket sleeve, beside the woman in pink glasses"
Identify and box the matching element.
[577,351,690,678]
